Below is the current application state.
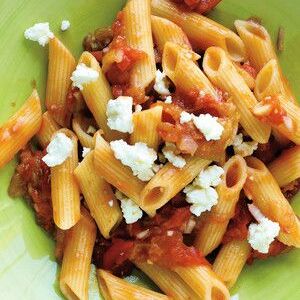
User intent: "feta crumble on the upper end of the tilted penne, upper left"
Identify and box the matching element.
[71,63,99,90]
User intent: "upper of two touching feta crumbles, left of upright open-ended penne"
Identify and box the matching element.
[193,165,224,188]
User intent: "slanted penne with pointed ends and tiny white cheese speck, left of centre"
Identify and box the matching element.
[74,151,123,239]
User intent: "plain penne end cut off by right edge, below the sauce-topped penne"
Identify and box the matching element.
[268,146,300,187]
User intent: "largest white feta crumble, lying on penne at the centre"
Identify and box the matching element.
[110,140,157,181]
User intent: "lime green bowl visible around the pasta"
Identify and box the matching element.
[0,0,300,300]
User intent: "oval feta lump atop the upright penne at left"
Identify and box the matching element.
[42,132,73,167]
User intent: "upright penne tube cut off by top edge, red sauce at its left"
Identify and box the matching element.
[123,0,156,89]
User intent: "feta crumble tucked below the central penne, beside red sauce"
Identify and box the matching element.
[115,191,143,224]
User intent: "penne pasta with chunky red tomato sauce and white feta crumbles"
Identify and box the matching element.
[0,0,300,300]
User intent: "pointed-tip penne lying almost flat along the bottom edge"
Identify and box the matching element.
[97,269,171,300]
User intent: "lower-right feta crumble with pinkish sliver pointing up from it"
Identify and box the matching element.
[248,204,280,253]
